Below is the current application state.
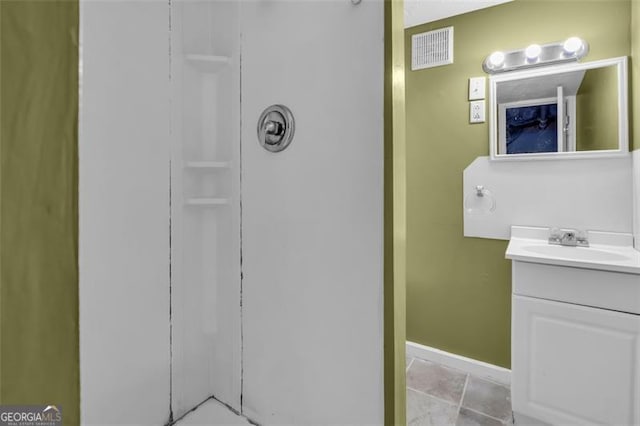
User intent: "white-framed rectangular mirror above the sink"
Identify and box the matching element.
[489,57,629,160]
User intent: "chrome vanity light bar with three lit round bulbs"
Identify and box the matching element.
[482,37,589,74]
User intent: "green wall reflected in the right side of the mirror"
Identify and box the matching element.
[576,67,618,151]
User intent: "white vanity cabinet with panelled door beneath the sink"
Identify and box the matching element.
[507,228,640,426]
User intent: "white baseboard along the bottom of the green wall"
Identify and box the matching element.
[406,342,511,386]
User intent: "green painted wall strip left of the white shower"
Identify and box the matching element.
[0,0,80,425]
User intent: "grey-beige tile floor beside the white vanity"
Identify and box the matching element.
[407,358,513,426]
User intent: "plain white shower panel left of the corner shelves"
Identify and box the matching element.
[78,0,170,425]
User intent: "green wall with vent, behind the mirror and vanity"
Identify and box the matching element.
[405,0,637,367]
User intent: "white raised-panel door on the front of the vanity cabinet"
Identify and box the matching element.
[511,296,640,425]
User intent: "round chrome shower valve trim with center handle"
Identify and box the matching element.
[258,105,295,152]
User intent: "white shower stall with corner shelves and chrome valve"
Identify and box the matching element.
[79,0,384,425]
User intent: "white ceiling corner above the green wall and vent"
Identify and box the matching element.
[404,0,512,28]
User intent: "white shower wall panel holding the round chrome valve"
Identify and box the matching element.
[241,0,384,425]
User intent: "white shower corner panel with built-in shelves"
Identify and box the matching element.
[171,0,241,418]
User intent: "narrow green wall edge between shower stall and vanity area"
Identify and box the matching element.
[384,0,407,426]
